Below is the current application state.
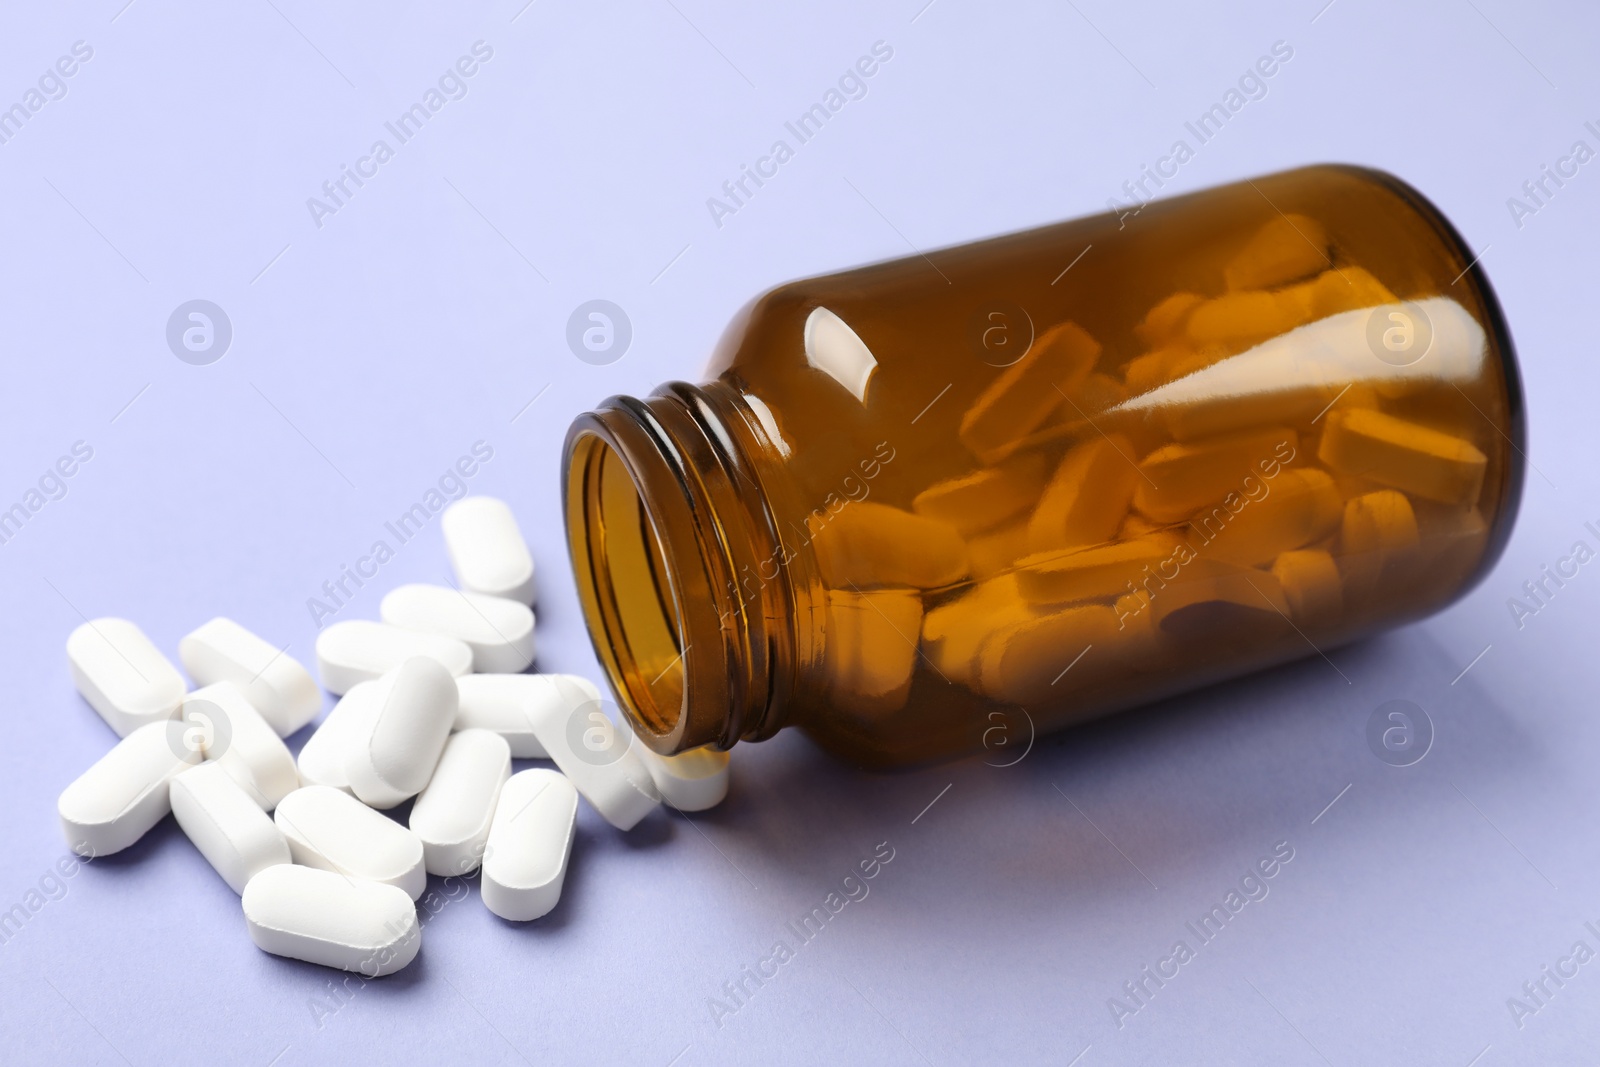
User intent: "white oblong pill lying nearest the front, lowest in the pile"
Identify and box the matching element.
[242,864,422,977]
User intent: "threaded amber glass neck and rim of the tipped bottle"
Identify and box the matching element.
[562,382,814,753]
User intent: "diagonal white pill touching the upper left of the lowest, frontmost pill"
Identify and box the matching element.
[171,763,293,893]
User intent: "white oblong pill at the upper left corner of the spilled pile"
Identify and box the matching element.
[67,619,189,737]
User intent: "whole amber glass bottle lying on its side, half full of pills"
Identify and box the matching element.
[563,166,1525,766]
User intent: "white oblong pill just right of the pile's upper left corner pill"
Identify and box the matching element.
[178,616,322,737]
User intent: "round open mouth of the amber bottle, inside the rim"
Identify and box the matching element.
[566,435,688,737]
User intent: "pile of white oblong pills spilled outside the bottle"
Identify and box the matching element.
[58,498,728,977]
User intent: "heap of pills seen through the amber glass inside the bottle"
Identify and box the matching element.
[806,214,1499,716]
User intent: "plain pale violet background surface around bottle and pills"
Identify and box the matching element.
[0,0,1600,1067]
